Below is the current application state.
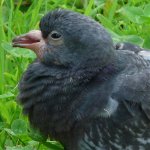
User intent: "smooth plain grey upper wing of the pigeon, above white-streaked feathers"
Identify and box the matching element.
[112,67,150,119]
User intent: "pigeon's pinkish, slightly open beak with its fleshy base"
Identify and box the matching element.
[12,30,45,59]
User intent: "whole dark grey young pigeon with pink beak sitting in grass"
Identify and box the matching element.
[13,10,150,150]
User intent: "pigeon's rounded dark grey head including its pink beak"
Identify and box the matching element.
[13,10,115,67]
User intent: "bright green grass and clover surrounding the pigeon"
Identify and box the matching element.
[0,0,150,150]
